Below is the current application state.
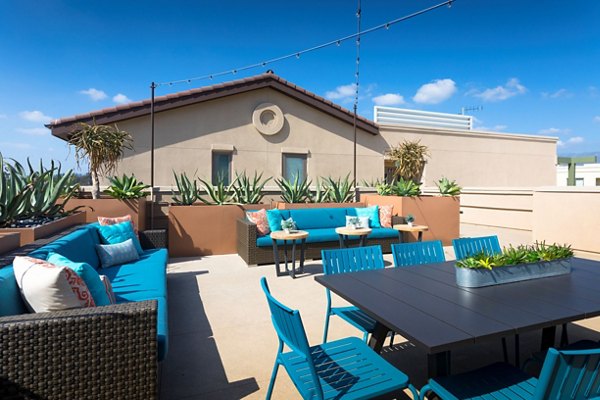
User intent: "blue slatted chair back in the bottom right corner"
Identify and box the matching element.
[534,348,600,400]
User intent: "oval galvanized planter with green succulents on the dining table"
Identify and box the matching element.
[455,242,573,287]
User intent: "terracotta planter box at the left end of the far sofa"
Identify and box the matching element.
[169,204,268,257]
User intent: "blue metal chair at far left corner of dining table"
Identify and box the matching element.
[321,246,385,343]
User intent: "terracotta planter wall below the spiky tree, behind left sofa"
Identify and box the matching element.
[66,198,146,231]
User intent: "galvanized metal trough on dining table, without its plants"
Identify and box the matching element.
[454,258,571,287]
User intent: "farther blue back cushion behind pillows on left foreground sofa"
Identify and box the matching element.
[29,224,100,269]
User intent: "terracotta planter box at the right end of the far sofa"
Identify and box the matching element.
[360,194,460,246]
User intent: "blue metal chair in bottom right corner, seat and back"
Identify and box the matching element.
[420,348,600,400]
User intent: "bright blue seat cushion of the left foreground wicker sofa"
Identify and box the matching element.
[102,249,169,361]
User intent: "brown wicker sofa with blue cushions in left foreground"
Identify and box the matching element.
[0,224,168,399]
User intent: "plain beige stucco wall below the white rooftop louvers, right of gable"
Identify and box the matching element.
[379,125,557,187]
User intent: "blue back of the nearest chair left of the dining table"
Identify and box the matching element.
[260,276,323,399]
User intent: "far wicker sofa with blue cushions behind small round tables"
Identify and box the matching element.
[237,208,400,265]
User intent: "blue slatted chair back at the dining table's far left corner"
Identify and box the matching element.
[321,245,385,275]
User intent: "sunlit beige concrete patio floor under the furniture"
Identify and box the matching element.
[160,227,600,400]
